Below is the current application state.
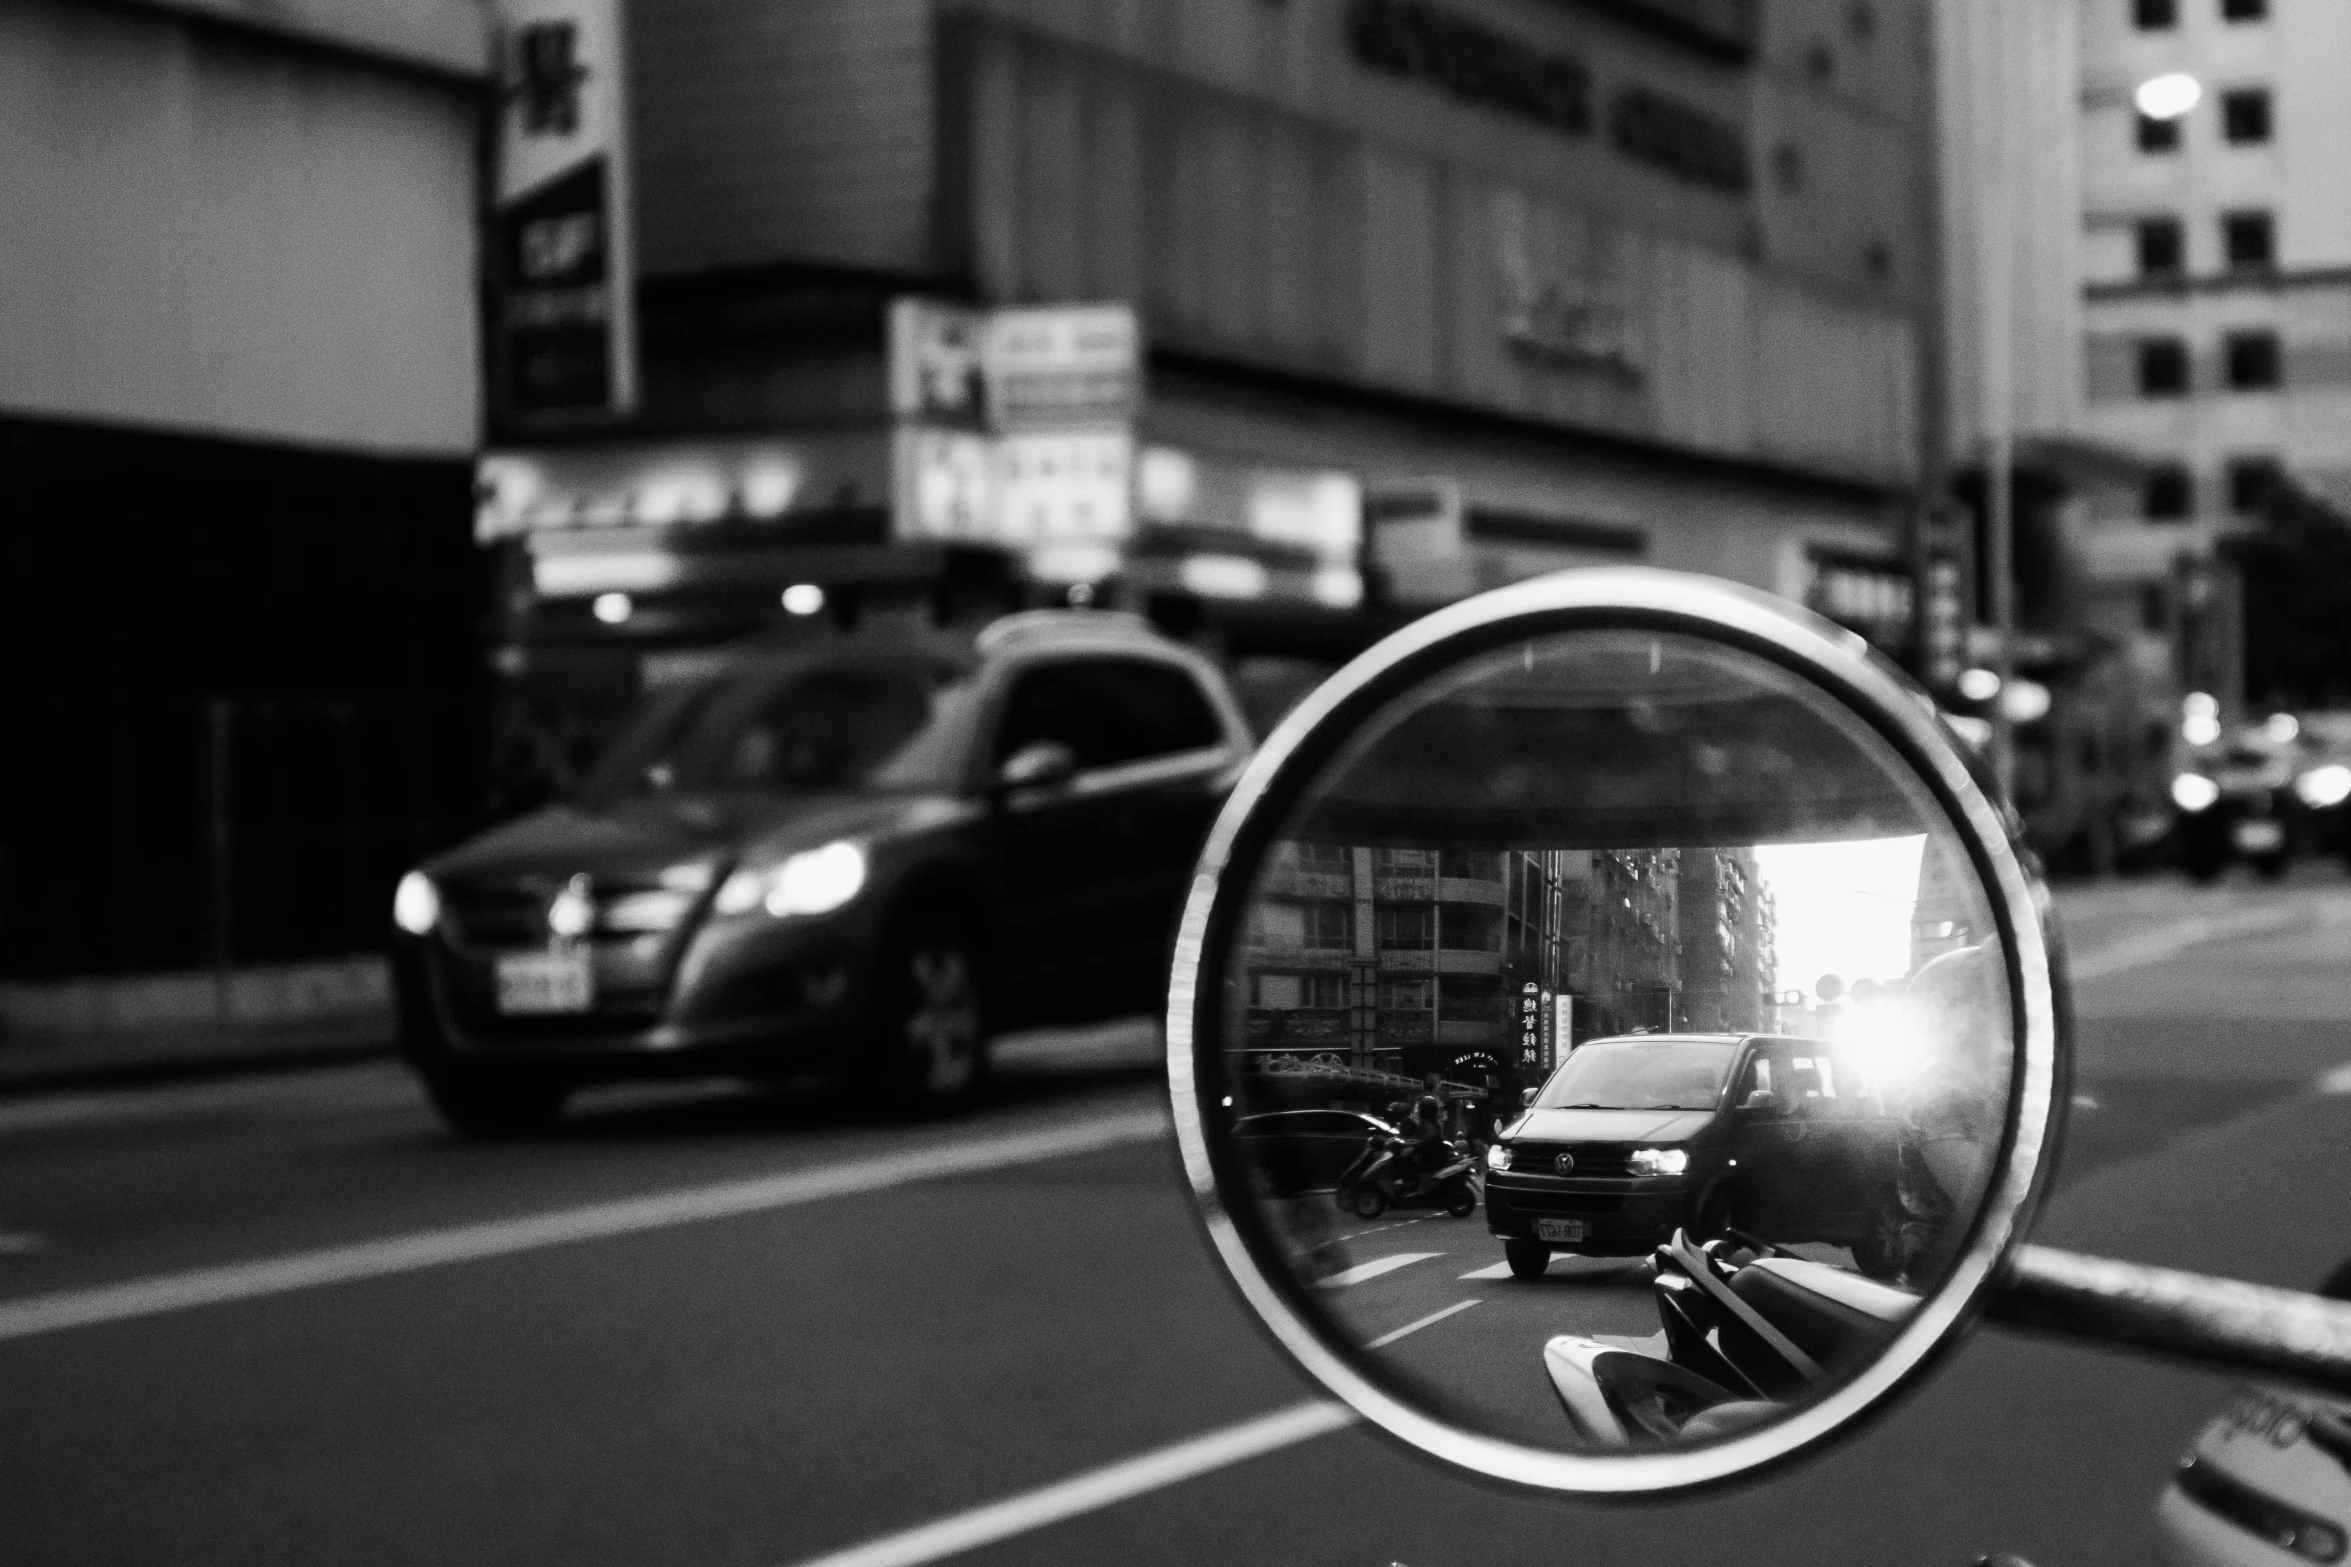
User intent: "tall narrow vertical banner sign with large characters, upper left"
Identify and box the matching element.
[489,0,637,423]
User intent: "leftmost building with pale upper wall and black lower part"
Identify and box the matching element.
[0,0,491,980]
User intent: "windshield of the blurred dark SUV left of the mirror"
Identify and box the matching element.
[581,663,973,806]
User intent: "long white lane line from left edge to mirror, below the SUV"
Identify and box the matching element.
[0,1109,1166,1341]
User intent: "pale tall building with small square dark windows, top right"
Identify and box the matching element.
[2081,0,2351,700]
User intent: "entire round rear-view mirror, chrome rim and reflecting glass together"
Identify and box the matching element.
[1168,571,2067,1494]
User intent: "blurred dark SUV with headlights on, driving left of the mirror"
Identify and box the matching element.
[393,611,1248,1132]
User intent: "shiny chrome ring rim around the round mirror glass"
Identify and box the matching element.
[1166,566,2069,1497]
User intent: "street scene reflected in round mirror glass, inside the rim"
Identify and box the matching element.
[1218,632,2015,1452]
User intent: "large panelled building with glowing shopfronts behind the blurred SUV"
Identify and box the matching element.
[482,0,1935,789]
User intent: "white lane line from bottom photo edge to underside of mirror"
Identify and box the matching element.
[795,1400,1357,1567]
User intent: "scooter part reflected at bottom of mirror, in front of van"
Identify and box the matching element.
[1542,1229,1918,1447]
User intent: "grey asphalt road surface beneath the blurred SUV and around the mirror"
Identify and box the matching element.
[0,876,2351,1567]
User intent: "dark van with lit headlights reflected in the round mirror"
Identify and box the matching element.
[1486,1034,1904,1278]
